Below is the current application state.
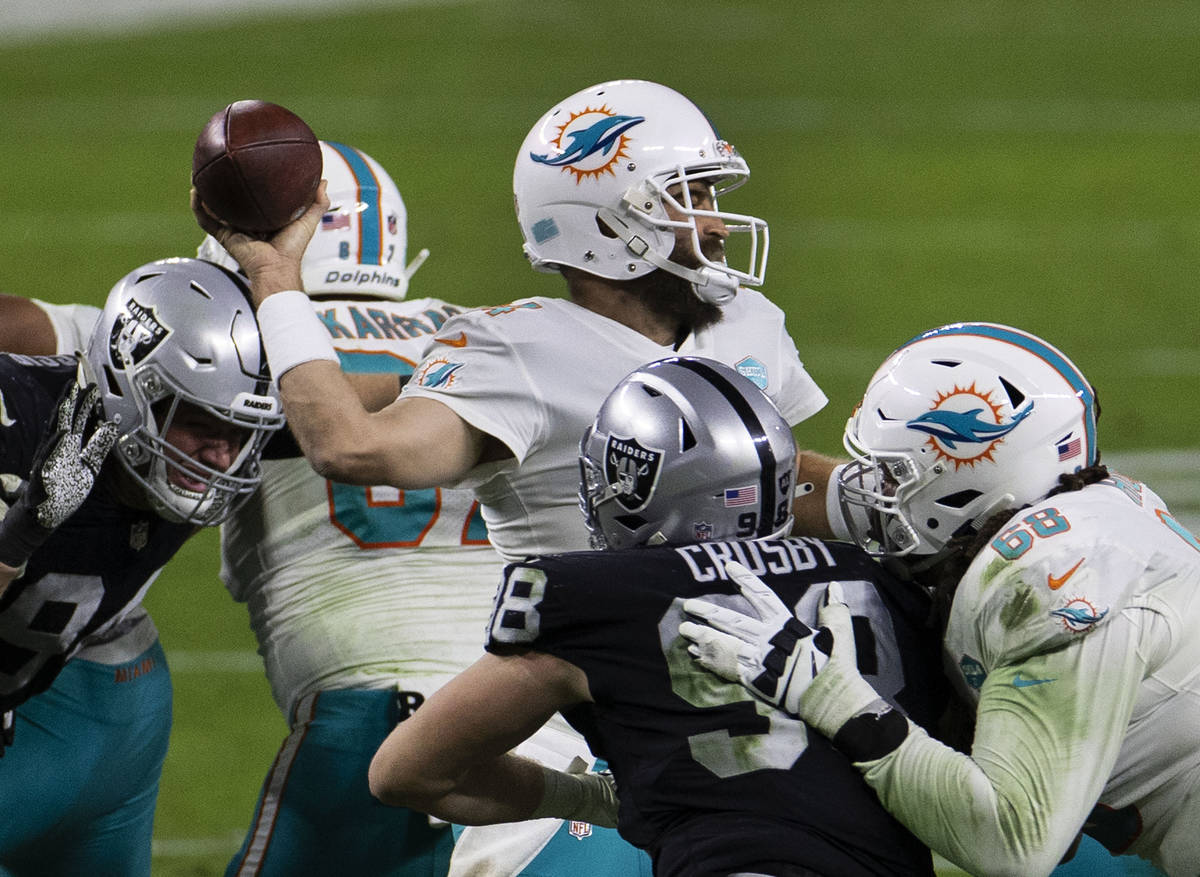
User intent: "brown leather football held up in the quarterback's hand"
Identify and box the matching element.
[192,101,322,235]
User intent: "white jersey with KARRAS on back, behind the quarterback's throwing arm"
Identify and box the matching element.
[221,299,500,716]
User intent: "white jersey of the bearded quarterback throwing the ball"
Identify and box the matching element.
[403,289,826,560]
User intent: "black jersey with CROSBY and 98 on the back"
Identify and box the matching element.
[487,539,946,877]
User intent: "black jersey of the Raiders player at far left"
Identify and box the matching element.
[0,354,196,711]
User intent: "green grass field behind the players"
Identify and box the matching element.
[0,0,1200,876]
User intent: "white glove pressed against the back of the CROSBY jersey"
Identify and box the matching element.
[679,560,830,716]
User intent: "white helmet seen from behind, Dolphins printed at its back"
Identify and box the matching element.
[197,140,430,300]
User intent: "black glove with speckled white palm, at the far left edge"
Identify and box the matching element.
[0,380,118,569]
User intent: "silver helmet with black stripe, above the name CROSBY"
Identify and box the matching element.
[580,356,796,548]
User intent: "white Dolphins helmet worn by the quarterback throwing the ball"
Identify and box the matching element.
[512,79,769,305]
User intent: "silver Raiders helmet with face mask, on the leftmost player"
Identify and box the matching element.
[84,259,284,527]
